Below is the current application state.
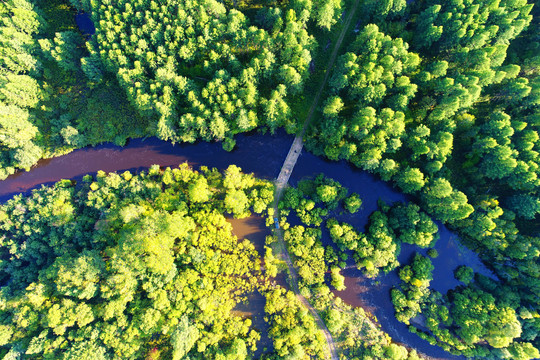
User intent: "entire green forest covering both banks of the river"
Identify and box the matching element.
[0,0,540,359]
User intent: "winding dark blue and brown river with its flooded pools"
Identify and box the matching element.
[0,131,493,359]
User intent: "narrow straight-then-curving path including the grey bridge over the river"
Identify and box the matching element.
[274,0,360,360]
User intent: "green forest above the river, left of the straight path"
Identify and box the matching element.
[0,0,342,179]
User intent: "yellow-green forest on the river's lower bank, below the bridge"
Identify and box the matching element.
[0,169,540,360]
